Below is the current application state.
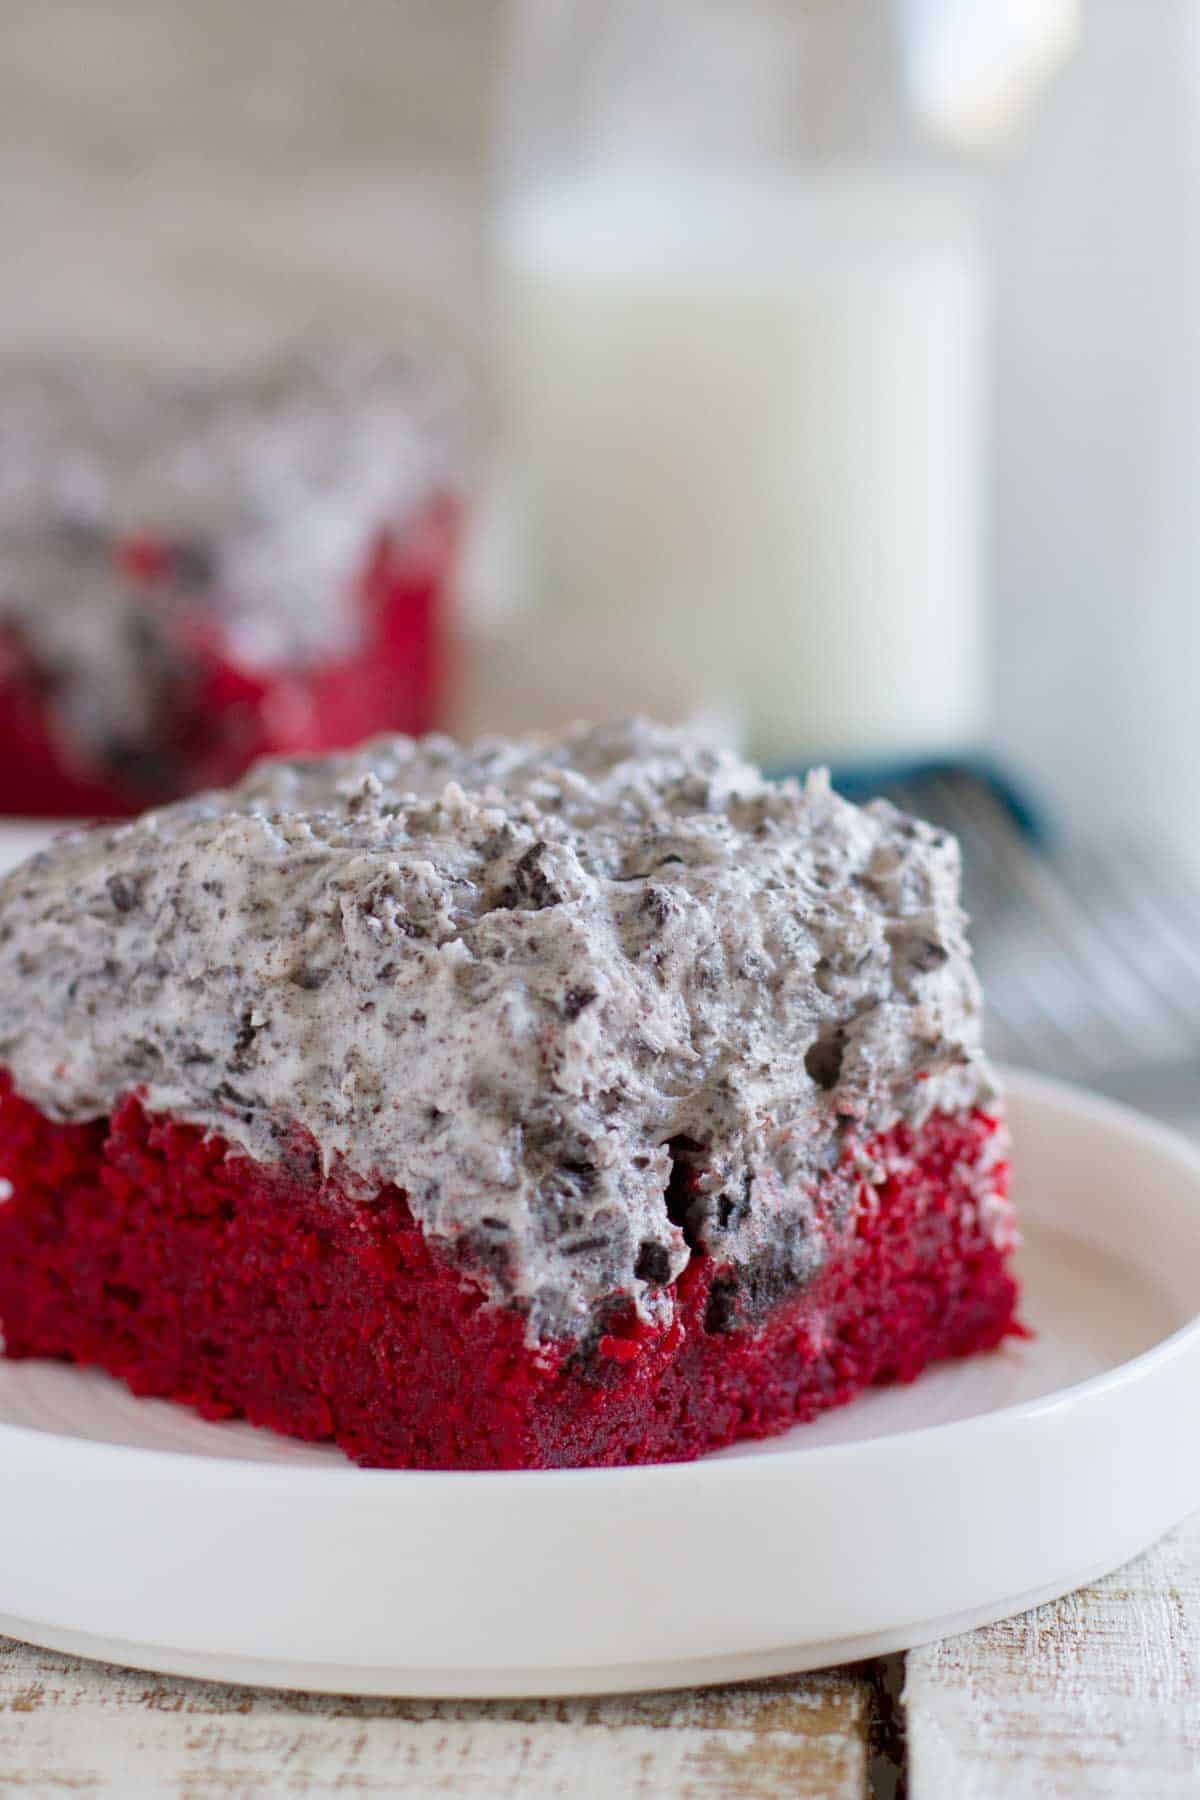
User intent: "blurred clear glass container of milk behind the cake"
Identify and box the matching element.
[484,0,1043,765]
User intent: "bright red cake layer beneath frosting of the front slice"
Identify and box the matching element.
[0,1082,1020,1469]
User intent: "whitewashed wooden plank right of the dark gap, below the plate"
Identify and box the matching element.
[905,1494,1200,1800]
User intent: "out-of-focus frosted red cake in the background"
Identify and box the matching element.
[0,349,462,815]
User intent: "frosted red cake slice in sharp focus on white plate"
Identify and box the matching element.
[0,725,1016,1469]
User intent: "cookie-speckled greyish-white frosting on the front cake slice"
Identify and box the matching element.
[0,724,1015,1353]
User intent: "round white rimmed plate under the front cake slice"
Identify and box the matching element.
[0,1076,1200,1696]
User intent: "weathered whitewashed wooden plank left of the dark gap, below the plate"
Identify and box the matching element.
[0,1638,871,1800]
